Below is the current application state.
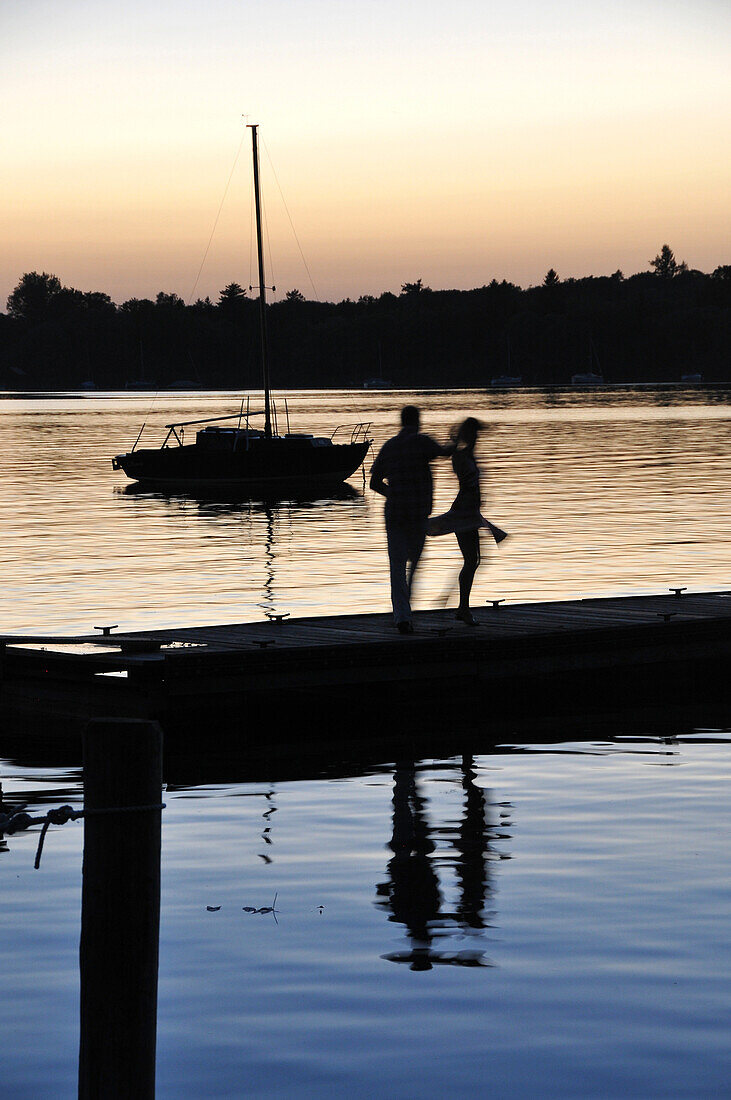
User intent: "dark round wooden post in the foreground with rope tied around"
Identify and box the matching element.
[79,718,163,1100]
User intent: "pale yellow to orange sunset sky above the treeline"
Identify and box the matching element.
[0,0,731,309]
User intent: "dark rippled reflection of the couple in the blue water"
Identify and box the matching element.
[377,756,499,970]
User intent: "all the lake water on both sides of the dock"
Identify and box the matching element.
[0,392,731,1100]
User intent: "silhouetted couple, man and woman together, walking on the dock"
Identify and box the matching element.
[370,405,506,634]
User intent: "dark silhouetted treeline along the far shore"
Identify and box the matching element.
[0,244,731,391]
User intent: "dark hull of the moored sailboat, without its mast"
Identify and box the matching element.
[112,437,370,490]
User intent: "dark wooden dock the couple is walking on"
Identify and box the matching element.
[0,590,731,745]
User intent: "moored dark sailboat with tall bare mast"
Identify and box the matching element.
[112,124,373,492]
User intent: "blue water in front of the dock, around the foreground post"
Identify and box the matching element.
[0,728,731,1098]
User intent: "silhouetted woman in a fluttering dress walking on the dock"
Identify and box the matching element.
[428,416,506,626]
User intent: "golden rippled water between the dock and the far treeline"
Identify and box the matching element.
[0,391,731,631]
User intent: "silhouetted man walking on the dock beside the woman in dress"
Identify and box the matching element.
[370,405,454,634]
